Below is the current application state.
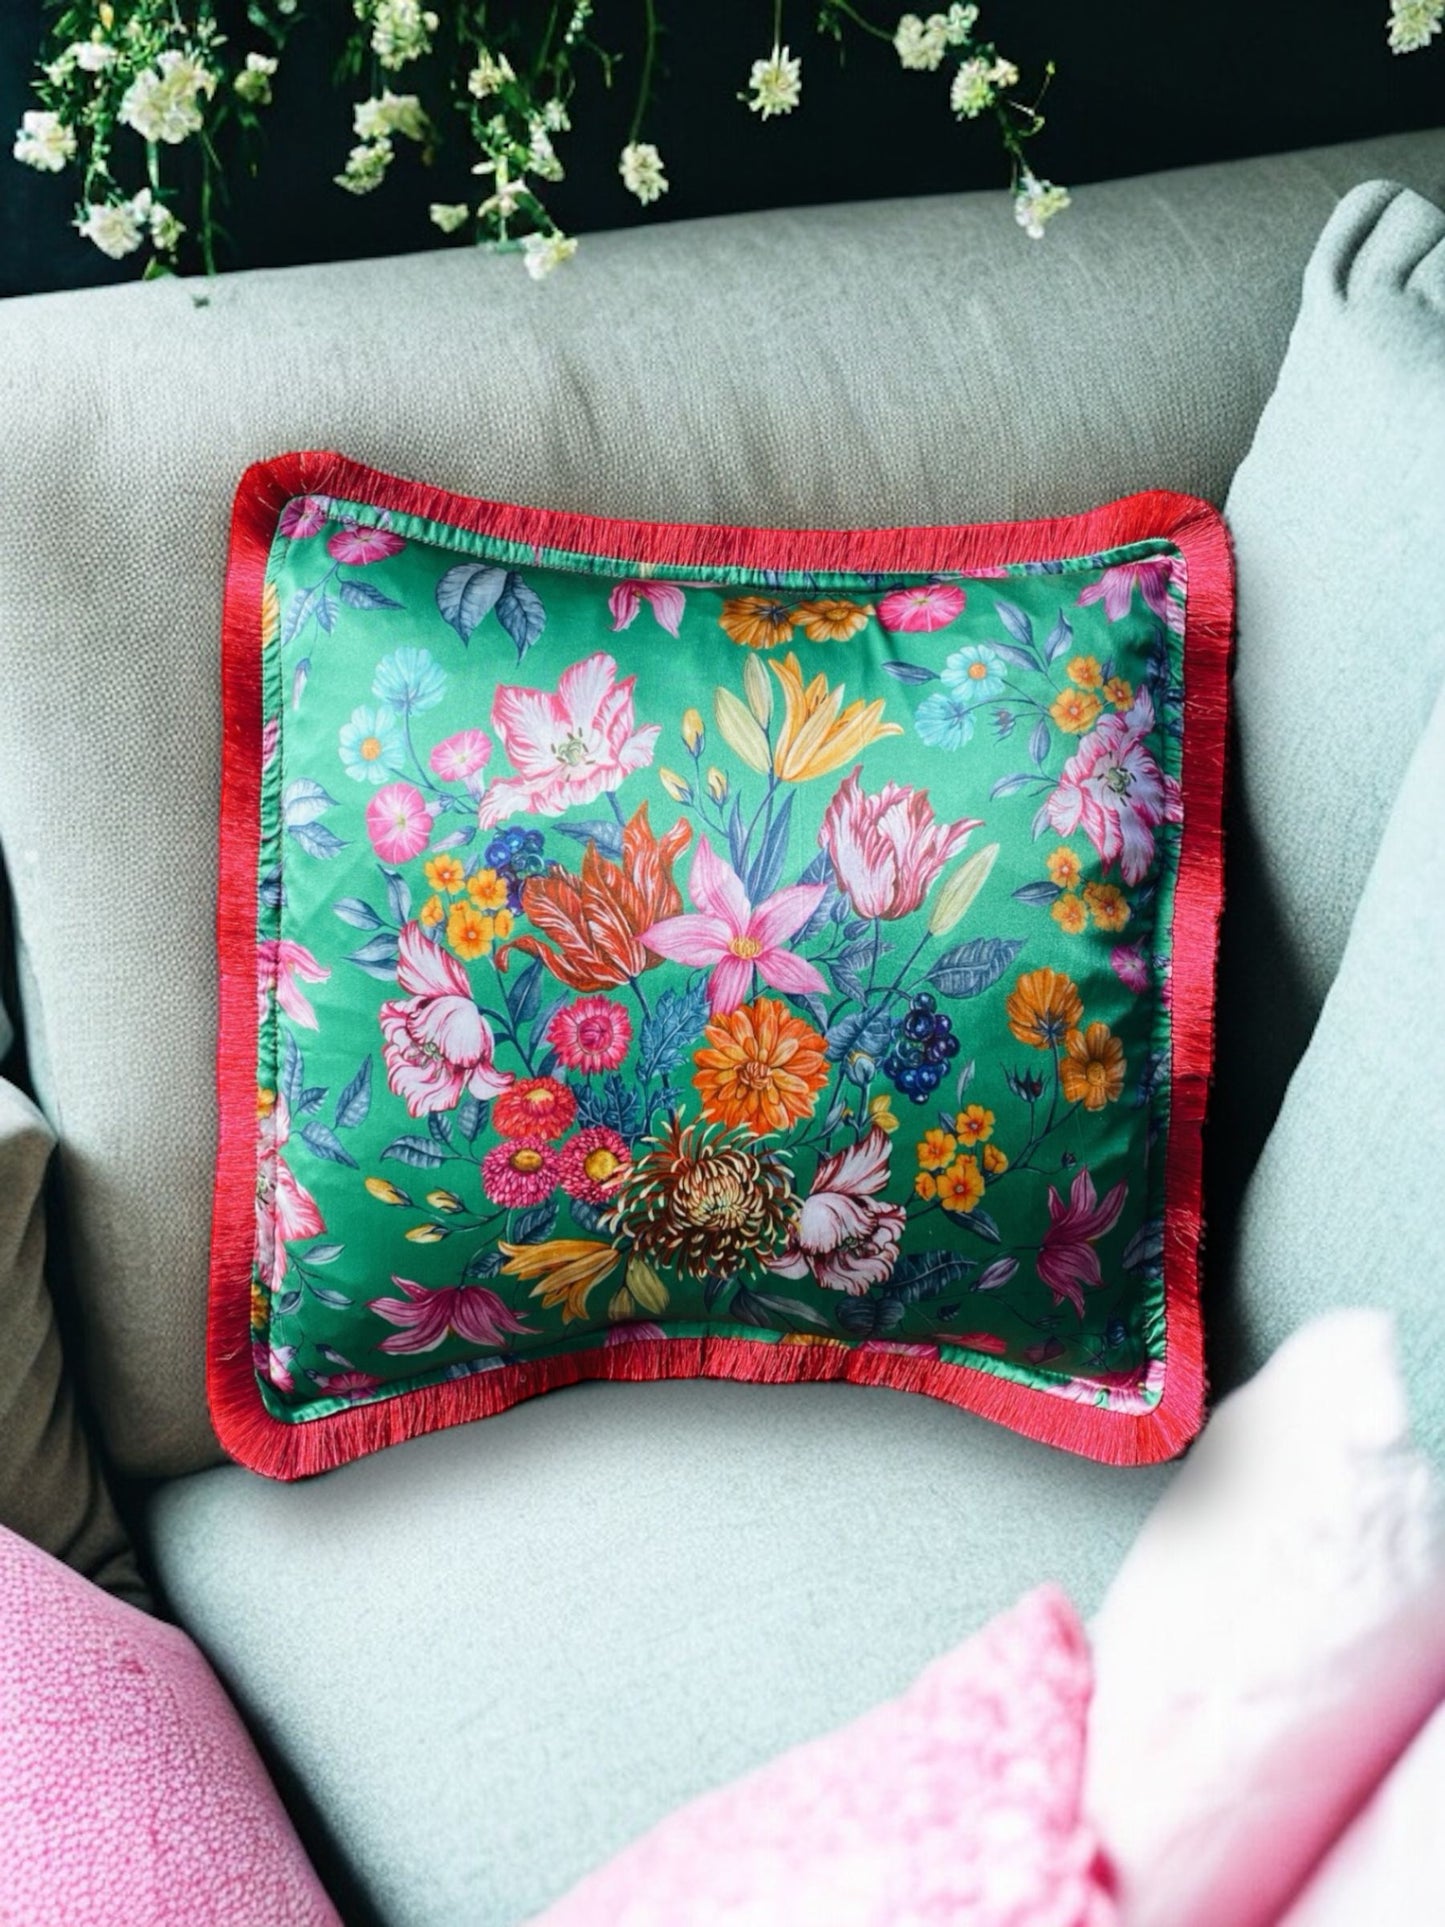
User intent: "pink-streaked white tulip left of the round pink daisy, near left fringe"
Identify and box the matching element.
[380,923,512,1118]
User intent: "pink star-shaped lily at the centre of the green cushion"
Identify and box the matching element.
[642,836,828,1017]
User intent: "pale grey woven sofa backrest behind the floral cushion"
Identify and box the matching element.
[0,133,1445,1474]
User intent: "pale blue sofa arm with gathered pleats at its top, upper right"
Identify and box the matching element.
[1212,181,1445,1210]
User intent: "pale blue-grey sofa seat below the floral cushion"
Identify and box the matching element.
[148,1380,1169,1927]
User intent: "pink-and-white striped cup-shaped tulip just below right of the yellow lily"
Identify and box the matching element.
[819,765,983,917]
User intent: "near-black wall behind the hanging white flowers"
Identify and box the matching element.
[0,0,1445,295]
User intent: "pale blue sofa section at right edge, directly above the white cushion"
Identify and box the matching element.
[1222,690,1445,1465]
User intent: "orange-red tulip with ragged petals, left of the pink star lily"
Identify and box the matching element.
[497,804,692,990]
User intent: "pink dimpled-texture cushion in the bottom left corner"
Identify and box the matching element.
[0,1528,339,1927]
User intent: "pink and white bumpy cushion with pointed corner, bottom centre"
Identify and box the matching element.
[536,1588,1117,1927]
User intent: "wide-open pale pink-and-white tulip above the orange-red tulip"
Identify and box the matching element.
[478,653,661,831]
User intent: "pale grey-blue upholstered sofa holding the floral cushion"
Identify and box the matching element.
[0,133,1445,1927]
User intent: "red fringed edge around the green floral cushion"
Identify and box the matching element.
[206,453,1233,1480]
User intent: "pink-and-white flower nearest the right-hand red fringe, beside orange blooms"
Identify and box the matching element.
[1044,690,1183,883]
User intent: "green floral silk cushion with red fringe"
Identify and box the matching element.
[210,455,1231,1478]
